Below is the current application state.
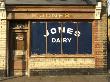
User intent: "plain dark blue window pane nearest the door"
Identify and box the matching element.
[31,22,46,54]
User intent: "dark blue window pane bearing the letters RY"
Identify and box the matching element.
[62,22,77,54]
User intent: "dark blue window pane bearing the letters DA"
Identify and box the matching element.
[47,22,61,54]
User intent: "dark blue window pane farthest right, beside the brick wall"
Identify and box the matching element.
[78,22,92,54]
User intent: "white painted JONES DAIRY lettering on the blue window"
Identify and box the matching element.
[44,27,81,43]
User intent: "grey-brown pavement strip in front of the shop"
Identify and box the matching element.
[0,75,110,82]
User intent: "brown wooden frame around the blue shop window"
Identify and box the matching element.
[30,20,94,58]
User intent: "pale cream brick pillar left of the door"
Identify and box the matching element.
[0,2,7,76]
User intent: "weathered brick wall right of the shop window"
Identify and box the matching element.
[94,0,107,68]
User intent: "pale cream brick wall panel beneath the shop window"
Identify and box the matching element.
[30,58,95,69]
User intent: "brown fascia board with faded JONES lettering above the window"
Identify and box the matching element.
[7,12,95,20]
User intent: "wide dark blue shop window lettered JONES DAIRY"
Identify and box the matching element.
[31,22,92,55]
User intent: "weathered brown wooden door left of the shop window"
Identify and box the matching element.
[9,31,27,76]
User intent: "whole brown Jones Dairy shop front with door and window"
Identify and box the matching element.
[0,0,104,76]
